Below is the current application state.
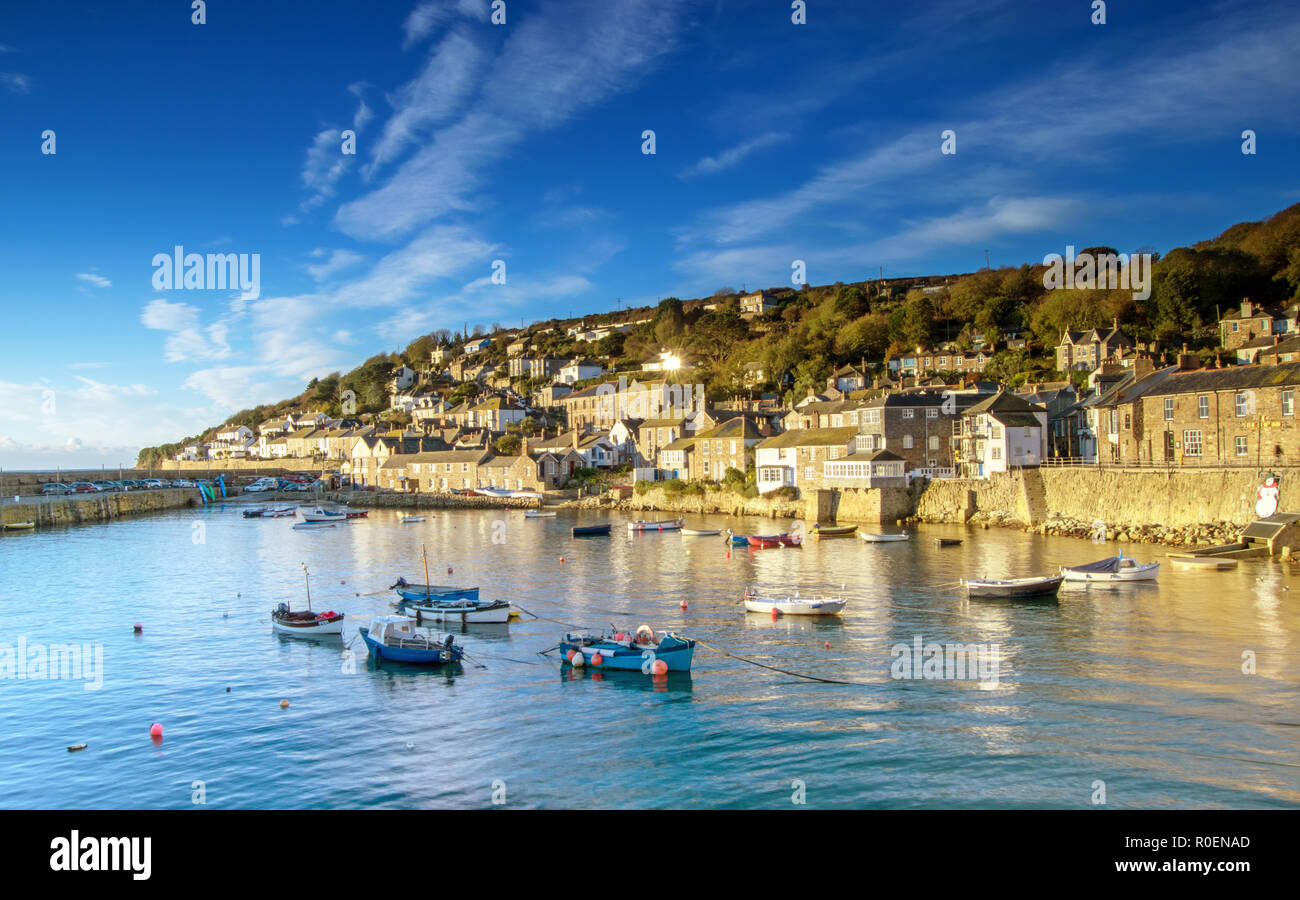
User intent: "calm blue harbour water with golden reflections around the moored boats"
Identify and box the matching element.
[0,506,1300,809]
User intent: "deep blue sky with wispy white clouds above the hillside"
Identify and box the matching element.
[0,0,1300,468]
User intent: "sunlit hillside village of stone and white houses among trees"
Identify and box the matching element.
[140,205,1300,497]
